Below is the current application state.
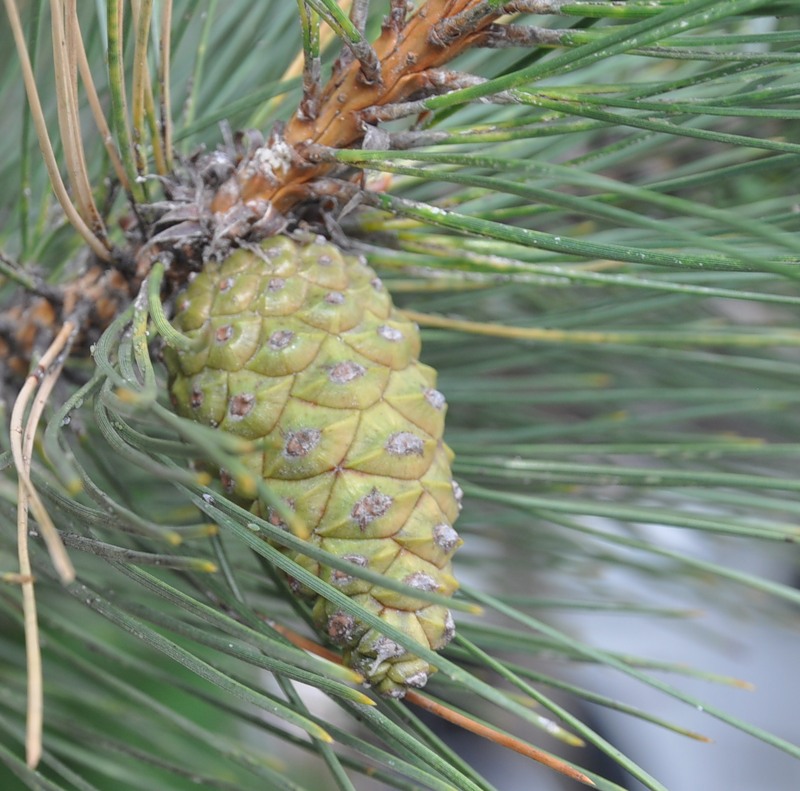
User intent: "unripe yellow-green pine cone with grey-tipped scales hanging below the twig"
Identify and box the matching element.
[164,237,461,697]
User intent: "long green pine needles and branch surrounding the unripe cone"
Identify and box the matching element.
[0,0,800,791]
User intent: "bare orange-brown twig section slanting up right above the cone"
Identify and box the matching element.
[211,0,528,214]
